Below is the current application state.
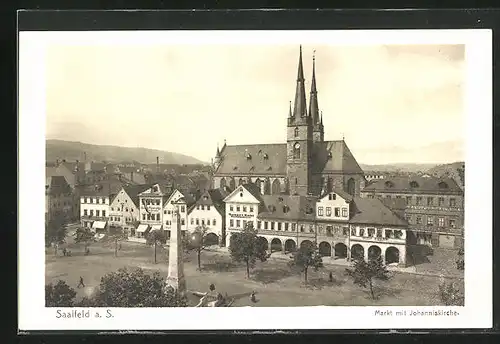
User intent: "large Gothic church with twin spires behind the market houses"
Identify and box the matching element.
[209,47,365,197]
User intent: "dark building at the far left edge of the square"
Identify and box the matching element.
[45,176,74,222]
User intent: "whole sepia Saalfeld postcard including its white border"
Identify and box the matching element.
[19,30,491,330]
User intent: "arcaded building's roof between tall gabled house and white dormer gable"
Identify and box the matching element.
[258,195,316,221]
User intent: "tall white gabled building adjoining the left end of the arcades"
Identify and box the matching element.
[224,184,261,246]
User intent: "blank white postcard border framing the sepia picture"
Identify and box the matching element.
[18,30,493,330]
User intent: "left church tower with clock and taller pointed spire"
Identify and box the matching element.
[287,46,313,196]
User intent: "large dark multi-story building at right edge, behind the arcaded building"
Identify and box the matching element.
[361,176,464,248]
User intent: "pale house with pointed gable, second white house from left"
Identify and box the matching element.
[109,185,151,236]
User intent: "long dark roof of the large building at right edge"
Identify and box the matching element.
[363,175,462,194]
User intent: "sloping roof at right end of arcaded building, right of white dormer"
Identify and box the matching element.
[349,197,408,227]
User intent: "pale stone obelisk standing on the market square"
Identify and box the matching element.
[167,201,186,296]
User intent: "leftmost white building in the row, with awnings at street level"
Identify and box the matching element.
[80,185,110,232]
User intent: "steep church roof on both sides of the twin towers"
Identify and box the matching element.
[215,140,363,176]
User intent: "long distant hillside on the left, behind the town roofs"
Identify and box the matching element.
[45,140,204,165]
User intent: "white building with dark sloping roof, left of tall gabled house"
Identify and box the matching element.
[188,189,228,246]
